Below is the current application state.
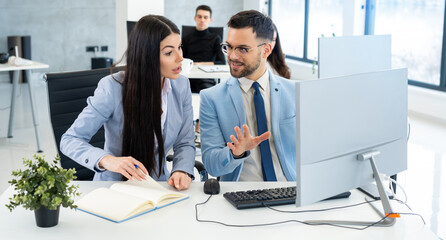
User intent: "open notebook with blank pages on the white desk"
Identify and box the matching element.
[75,176,189,223]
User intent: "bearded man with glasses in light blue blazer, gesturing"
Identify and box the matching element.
[200,10,296,181]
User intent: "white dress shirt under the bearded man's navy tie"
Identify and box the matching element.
[238,71,287,181]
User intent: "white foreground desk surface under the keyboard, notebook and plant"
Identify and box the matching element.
[0,182,438,240]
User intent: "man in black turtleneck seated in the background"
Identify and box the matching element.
[182,5,225,93]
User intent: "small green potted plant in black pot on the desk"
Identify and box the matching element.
[6,155,80,227]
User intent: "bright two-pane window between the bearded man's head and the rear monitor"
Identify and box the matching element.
[270,0,343,62]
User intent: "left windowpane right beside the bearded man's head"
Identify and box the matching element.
[270,0,305,58]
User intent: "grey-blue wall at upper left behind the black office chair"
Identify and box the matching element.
[0,0,116,77]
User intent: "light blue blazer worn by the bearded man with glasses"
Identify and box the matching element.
[200,72,296,181]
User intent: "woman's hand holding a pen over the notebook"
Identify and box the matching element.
[99,155,148,181]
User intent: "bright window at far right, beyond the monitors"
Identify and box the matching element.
[375,0,445,86]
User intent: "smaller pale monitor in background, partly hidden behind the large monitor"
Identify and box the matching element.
[318,35,392,78]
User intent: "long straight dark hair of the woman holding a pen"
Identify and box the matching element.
[121,15,180,177]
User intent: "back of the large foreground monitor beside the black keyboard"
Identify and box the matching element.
[296,69,407,226]
